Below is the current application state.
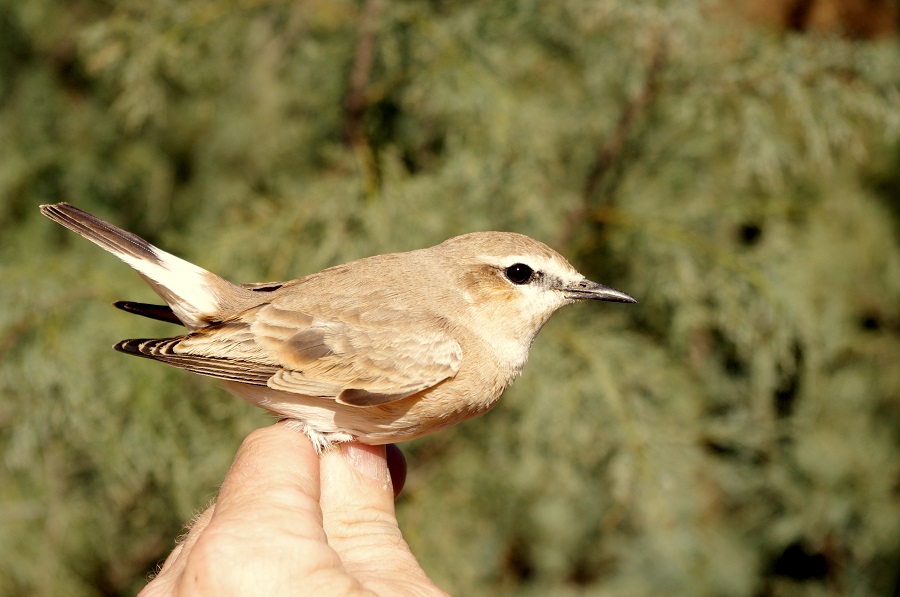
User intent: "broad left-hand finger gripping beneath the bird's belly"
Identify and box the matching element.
[177,424,355,595]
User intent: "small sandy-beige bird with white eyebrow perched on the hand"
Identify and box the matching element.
[40,203,637,452]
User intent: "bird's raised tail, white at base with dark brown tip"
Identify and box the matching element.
[41,203,241,329]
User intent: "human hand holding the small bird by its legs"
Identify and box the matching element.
[139,423,445,597]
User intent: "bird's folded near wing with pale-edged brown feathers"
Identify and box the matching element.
[116,304,462,406]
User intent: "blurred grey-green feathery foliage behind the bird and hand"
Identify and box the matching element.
[0,0,900,597]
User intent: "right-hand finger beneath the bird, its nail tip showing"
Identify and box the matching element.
[320,442,439,594]
